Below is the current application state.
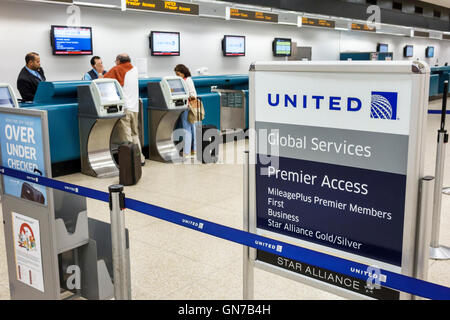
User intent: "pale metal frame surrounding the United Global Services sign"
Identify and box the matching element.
[244,61,430,299]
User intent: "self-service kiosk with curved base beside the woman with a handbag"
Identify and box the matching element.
[147,76,189,162]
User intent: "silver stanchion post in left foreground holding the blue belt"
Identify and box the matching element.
[109,185,131,300]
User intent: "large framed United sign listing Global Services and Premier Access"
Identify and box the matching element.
[250,62,427,298]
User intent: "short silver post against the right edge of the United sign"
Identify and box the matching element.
[414,176,434,300]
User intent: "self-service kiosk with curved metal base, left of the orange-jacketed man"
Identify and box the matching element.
[78,79,125,178]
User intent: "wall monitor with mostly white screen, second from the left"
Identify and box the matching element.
[150,31,180,56]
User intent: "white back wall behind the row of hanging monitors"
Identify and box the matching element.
[0,0,450,97]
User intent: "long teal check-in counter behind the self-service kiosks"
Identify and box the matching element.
[20,75,248,177]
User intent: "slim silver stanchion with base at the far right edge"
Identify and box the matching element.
[430,81,450,260]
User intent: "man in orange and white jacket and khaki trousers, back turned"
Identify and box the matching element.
[104,53,145,165]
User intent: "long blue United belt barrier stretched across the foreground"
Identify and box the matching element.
[0,166,450,300]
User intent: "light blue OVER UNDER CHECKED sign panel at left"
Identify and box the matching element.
[0,112,47,205]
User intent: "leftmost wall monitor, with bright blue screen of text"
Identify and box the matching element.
[51,26,93,56]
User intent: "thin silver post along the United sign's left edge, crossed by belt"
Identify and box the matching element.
[242,151,254,300]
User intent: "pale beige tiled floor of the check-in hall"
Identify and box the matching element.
[0,101,450,300]
